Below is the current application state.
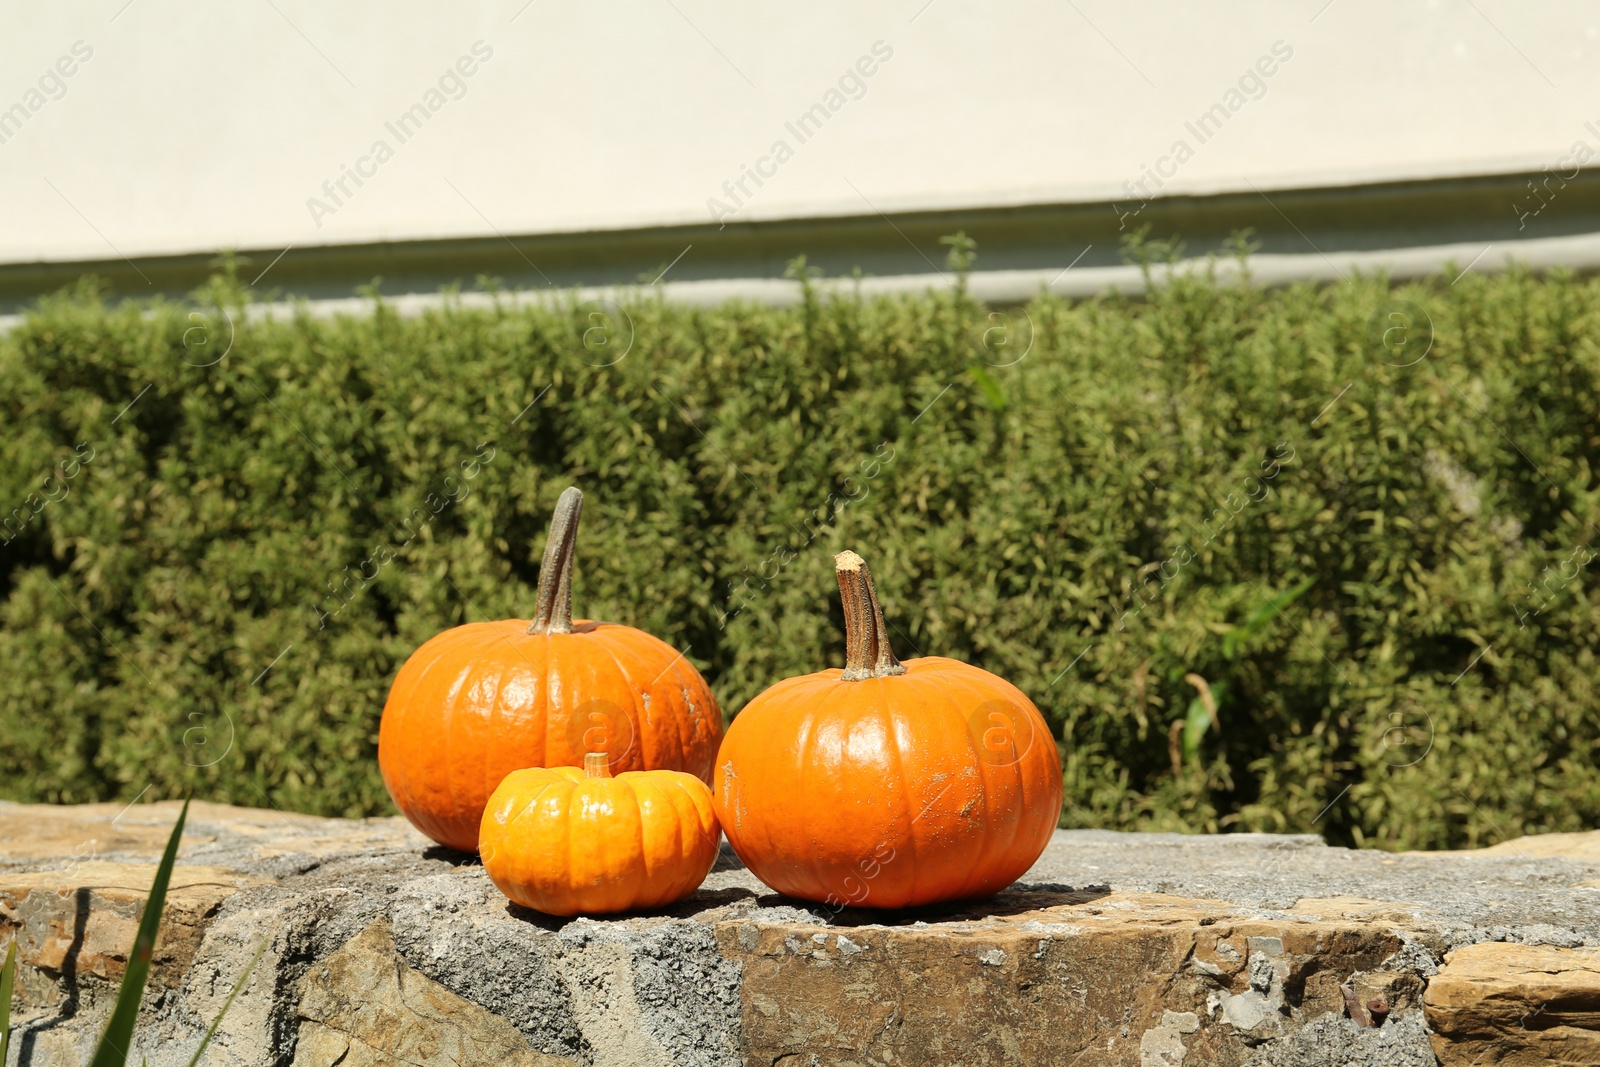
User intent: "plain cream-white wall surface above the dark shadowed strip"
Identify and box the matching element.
[0,0,1600,262]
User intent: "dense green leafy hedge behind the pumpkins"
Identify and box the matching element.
[0,254,1600,848]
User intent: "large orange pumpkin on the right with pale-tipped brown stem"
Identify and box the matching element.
[714,552,1061,907]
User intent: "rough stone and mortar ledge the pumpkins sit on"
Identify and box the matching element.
[0,803,1600,1067]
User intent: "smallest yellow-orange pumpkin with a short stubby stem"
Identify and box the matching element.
[478,753,722,915]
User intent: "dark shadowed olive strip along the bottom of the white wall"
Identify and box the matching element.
[0,171,1600,314]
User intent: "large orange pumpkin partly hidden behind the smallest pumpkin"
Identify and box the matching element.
[378,490,722,851]
